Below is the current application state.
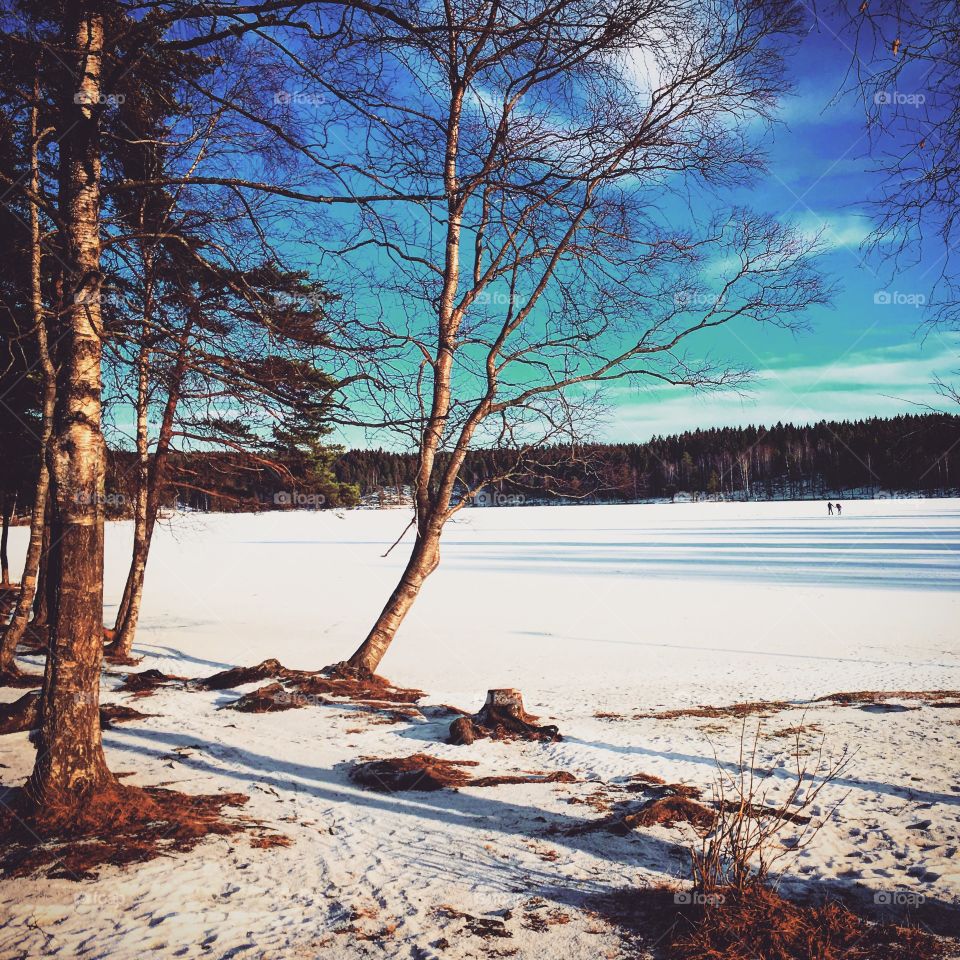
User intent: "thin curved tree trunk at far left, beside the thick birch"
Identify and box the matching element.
[0,94,57,673]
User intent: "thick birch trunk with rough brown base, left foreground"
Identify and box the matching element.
[27,9,115,808]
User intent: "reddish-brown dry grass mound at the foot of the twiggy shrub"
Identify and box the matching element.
[667,886,947,960]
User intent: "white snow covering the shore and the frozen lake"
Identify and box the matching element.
[0,500,960,960]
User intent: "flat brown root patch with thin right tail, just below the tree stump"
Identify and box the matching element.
[350,753,577,793]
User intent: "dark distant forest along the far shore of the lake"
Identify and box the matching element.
[97,413,960,516]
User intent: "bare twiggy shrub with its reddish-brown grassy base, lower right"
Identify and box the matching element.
[667,720,947,960]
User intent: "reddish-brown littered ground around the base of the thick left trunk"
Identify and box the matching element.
[0,783,250,880]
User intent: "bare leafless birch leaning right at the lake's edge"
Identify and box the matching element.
[284,0,828,672]
